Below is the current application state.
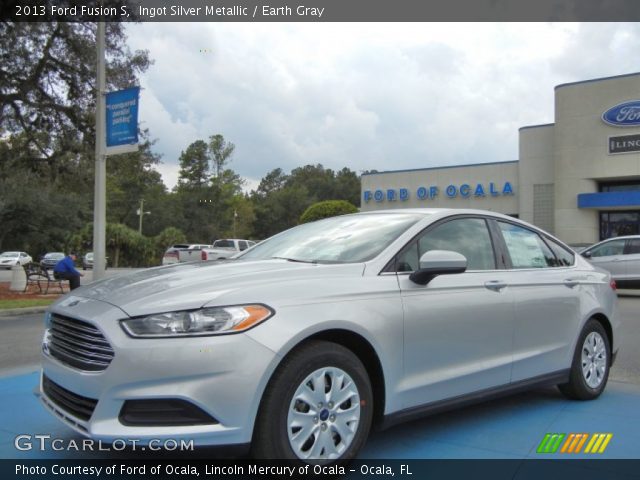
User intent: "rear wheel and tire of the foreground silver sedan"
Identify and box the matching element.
[558,318,611,400]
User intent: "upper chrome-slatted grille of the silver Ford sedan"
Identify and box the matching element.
[47,315,113,372]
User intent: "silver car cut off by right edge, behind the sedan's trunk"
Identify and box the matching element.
[580,235,640,288]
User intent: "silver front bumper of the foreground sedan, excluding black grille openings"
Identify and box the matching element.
[39,297,276,445]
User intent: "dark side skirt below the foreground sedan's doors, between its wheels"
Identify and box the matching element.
[376,369,570,430]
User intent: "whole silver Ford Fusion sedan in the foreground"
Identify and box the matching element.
[40,209,620,462]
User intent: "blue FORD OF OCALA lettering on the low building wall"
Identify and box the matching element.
[362,182,514,203]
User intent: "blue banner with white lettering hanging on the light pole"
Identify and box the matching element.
[105,87,140,148]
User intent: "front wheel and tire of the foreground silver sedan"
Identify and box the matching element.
[252,341,373,464]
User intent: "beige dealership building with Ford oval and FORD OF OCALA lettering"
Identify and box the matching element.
[361,73,640,245]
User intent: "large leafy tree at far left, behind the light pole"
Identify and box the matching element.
[0,22,150,254]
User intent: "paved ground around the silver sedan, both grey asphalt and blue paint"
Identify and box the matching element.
[0,297,640,466]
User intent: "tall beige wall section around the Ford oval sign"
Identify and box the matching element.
[553,74,640,243]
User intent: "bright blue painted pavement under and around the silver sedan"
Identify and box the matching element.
[0,372,640,463]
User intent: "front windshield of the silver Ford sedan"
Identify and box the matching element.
[238,213,424,263]
